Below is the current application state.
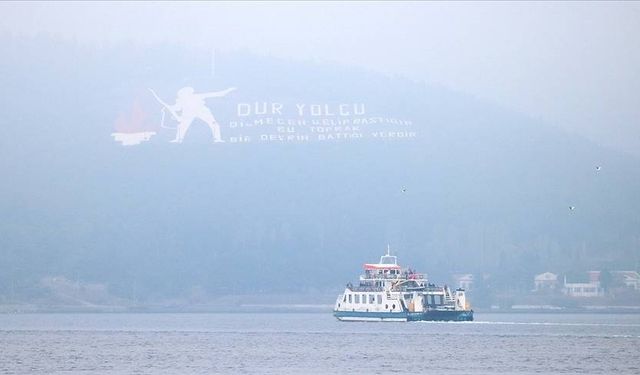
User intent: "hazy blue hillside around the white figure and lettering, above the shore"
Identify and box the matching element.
[0,36,640,304]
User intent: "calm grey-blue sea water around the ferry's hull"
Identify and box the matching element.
[0,313,640,374]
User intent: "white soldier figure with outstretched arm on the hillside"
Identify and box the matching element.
[149,87,236,143]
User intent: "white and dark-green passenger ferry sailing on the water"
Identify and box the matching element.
[333,247,473,322]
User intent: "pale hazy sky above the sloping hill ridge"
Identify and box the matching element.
[0,2,640,155]
